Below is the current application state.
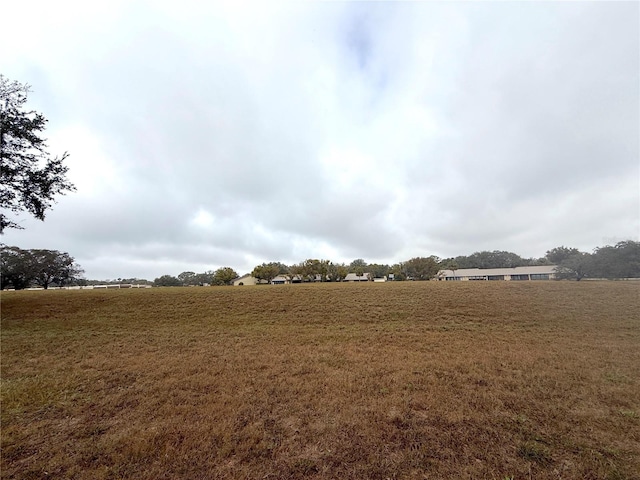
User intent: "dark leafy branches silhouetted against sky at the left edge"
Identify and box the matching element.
[0,75,75,234]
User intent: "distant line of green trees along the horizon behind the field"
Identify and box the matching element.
[0,240,640,290]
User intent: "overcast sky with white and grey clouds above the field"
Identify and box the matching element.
[0,0,640,280]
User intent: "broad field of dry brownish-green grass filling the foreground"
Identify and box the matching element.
[1,282,640,480]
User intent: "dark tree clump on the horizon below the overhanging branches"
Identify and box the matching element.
[0,246,83,290]
